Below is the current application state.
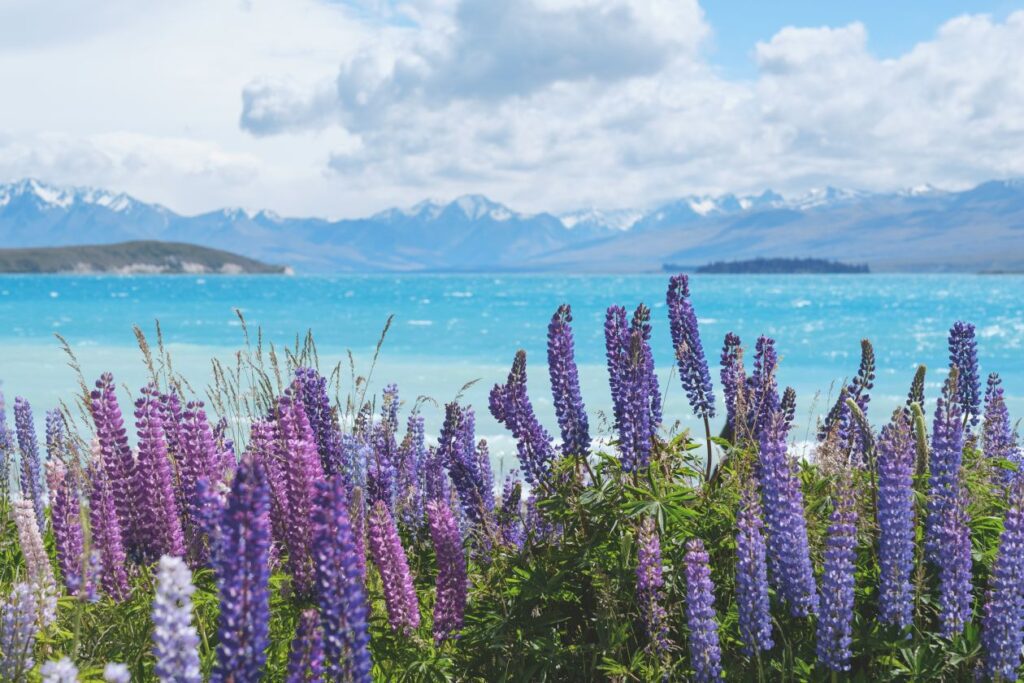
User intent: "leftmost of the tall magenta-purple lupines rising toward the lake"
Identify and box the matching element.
[90,373,145,555]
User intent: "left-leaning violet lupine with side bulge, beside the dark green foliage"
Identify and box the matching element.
[489,349,555,485]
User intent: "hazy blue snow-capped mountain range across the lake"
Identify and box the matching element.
[0,178,1024,272]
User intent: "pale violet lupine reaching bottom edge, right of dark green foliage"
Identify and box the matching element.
[684,539,722,683]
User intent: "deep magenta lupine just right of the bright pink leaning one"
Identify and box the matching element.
[427,501,469,645]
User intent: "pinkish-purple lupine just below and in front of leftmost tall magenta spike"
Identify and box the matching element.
[89,442,128,601]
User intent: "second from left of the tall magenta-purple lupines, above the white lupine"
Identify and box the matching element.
[135,384,185,562]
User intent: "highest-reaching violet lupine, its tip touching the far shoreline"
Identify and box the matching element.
[667,274,715,418]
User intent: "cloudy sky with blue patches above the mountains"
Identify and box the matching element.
[0,0,1024,217]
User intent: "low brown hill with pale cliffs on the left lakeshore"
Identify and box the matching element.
[0,241,286,274]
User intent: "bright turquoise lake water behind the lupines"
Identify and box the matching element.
[0,274,1024,468]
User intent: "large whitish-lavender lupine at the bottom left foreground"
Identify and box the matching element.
[153,555,200,683]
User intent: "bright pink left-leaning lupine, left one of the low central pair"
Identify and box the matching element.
[367,501,420,635]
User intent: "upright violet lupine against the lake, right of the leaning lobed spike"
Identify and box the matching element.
[548,304,590,458]
